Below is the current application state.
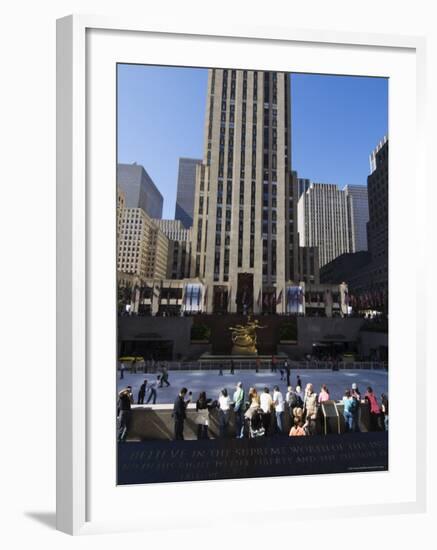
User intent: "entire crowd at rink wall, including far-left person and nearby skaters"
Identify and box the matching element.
[118,370,389,441]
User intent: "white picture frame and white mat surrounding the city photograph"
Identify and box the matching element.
[56,15,427,534]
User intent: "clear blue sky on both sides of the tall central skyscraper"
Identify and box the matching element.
[118,65,388,218]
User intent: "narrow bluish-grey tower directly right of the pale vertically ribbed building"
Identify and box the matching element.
[344,185,369,252]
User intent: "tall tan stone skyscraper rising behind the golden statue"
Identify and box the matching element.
[191,69,298,313]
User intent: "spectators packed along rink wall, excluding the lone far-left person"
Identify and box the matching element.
[158,377,388,440]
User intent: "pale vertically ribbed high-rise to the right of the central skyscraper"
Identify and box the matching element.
[298,183,351,267]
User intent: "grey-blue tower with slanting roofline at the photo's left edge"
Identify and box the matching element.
[117,164,163,218]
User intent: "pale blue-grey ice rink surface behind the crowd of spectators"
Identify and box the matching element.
[117,369,388,404]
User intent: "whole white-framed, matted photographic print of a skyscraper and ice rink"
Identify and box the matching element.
[57,16,426,534]
